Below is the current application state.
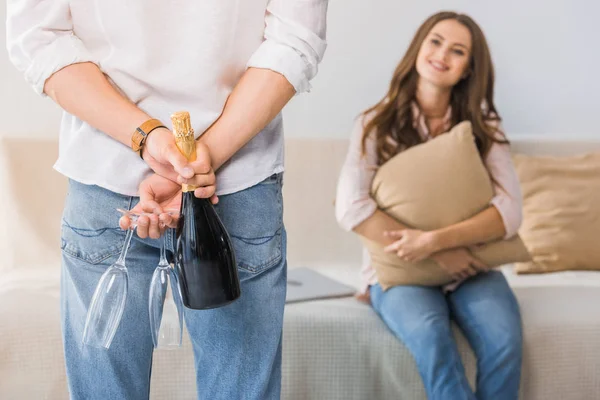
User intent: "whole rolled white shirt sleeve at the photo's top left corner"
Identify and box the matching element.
[6,0,95,95]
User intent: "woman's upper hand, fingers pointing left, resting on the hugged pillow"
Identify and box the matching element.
[384,229,438,262]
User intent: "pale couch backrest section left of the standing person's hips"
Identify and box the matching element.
[0,137,67,270]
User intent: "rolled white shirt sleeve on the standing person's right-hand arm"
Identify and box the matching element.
[247,0,328,94]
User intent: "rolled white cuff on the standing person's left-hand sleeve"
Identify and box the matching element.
[25,34,95,96]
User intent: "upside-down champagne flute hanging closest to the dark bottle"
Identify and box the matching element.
[148,234,183,349]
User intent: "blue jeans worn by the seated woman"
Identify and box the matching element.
[371,271,522,400]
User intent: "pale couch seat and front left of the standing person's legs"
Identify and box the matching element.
[0,265,68,400]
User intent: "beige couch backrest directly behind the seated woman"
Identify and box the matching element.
[283,136,600,271]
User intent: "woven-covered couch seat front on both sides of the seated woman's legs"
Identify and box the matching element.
[283,286,600,400]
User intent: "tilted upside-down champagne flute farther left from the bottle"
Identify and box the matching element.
[83,225,135,349]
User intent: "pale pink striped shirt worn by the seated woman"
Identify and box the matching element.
[335,104,522,289]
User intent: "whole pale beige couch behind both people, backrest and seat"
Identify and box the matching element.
[0,138,600,400]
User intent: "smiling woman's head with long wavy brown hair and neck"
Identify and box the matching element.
[362,12,506,165]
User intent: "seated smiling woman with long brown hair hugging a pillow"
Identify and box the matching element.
[336,12,522,400]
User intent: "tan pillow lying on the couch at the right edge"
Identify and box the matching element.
[513,153,600,274]
